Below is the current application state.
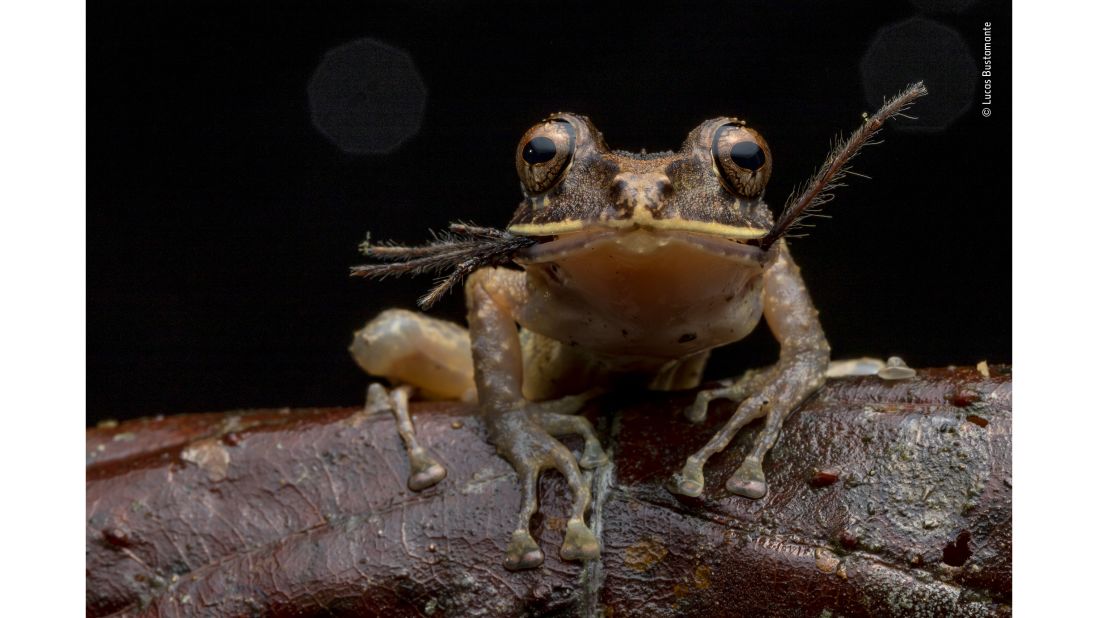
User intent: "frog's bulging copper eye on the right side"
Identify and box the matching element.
[713,123,771,198]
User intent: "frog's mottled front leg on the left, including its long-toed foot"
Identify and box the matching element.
[466,268,604,570]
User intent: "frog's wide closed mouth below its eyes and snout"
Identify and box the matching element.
[514,227,769,267]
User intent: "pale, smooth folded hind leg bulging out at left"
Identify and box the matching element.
[350,310,477,402]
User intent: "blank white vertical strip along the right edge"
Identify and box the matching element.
[1010,2,1098,616]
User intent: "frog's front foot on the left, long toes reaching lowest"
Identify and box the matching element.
[488,396,606,571]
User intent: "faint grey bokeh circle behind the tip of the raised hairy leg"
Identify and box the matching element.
[862,18,982,131]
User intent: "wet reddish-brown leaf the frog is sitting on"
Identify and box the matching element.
[87,367,1011,617]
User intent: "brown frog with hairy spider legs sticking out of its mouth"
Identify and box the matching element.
[350,83,926,571]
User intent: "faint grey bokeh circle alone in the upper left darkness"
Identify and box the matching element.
[307,38,427,154]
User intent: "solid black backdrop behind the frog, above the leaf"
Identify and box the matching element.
[87,0,1010,423]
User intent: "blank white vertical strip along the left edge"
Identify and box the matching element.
[0,2,87,616]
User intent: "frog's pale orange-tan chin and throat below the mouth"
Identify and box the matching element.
[515,228,772,358]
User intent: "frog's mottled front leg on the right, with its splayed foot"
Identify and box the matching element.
[671,243,830,498]
